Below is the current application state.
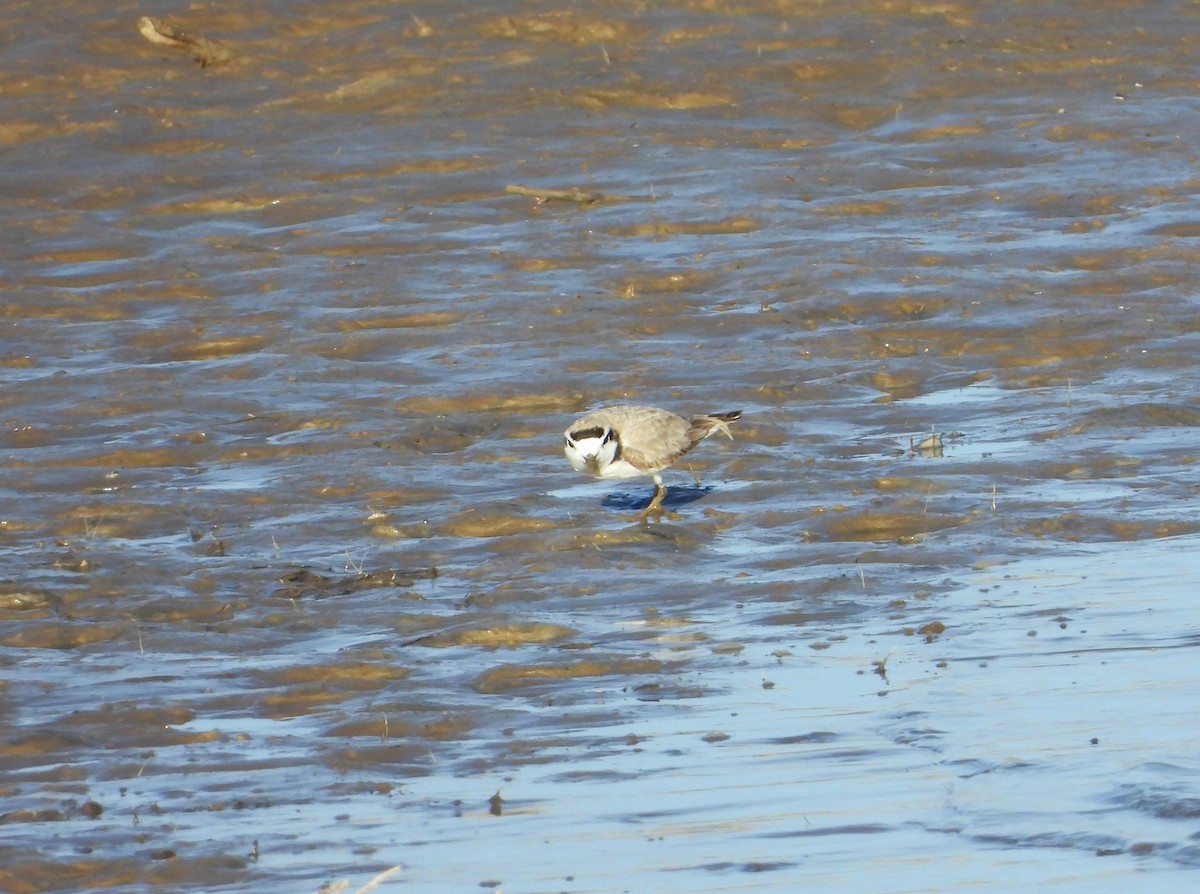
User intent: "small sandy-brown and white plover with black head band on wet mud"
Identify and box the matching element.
[563,406,742,522]
